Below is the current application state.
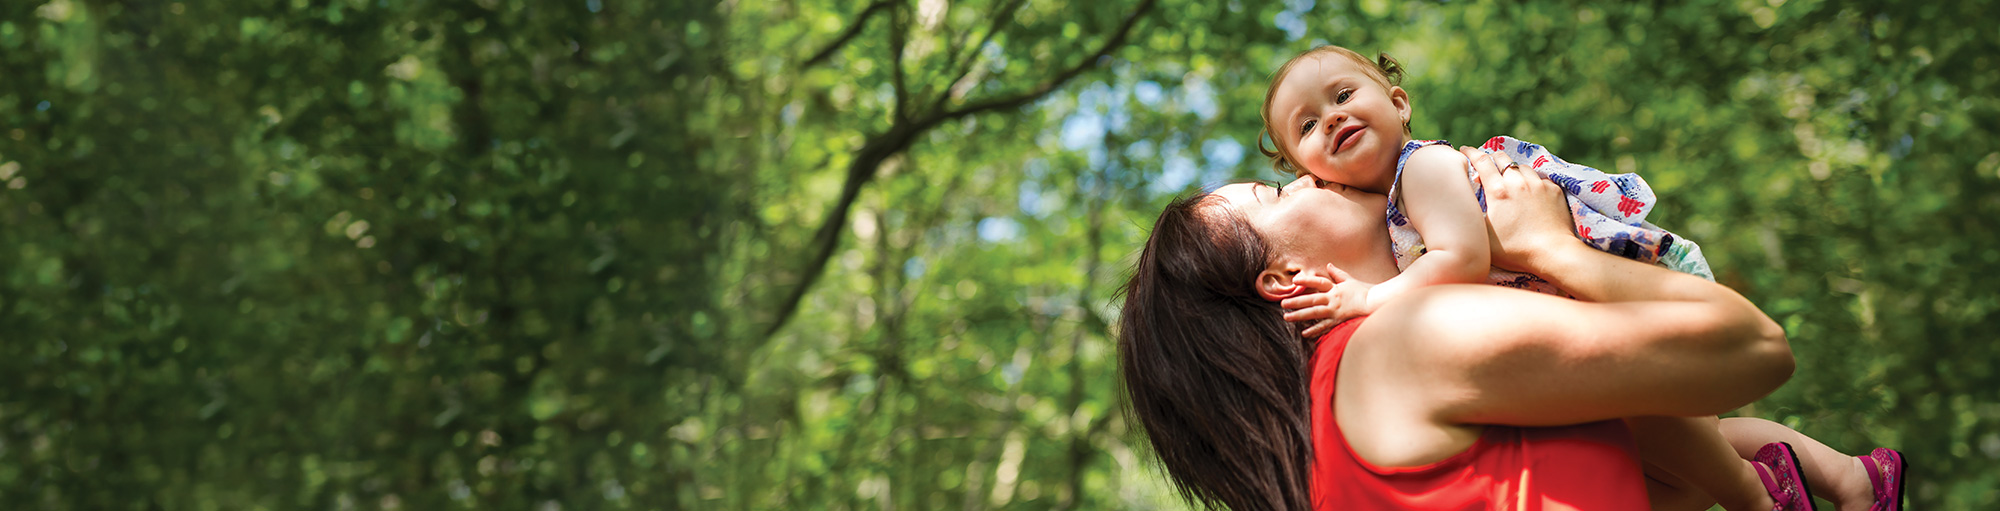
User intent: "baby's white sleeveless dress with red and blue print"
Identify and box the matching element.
[1388,136,1716,295]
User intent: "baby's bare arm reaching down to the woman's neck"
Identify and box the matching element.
[1366,146,1492,311]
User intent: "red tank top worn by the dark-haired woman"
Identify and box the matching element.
[1312,317,1648,511]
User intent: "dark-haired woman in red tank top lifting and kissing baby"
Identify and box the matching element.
[1120,152,1792,511]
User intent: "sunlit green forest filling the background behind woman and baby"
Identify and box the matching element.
[0,0,2000,511]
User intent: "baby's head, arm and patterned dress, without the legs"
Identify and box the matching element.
[1258,46,1714,329]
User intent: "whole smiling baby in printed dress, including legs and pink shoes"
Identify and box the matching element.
[1258,46,1902,511]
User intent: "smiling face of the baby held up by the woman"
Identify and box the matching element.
[1264,54,1410,194]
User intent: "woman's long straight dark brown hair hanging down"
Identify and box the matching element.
[1118,194,1312,511]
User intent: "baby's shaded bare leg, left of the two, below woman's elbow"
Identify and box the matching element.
[1624,417,1772,511]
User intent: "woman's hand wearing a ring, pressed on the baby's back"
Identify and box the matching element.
[1458,148,1588,273]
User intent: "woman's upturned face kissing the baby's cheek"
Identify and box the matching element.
[1216,176,1396,283]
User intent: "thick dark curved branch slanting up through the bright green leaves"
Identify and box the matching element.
[764,0,1158,337]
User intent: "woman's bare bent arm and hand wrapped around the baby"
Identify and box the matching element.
[1342,150,1792,425]
